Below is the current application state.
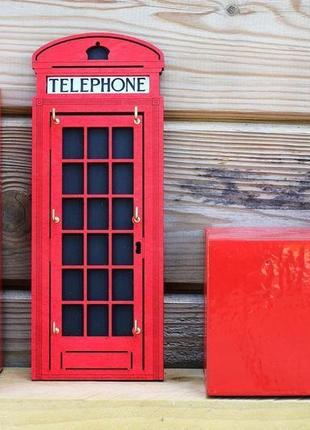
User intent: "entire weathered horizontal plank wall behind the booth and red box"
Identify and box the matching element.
[0,0,310,367]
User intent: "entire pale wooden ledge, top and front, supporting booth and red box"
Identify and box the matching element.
[0,369,310,430]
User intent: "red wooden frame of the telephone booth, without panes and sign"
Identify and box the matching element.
[32,33,163,380]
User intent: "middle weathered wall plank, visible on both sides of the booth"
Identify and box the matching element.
[3,118,310,284]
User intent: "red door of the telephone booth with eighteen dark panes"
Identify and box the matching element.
[50,115,143,372]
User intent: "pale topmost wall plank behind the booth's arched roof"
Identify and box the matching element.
[0,0,310,118]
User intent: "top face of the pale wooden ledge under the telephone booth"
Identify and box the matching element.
[0,367,206,402]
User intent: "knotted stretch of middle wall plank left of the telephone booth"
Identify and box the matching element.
[1,120,31,279]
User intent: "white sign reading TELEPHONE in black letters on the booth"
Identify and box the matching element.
[47,76,150,94]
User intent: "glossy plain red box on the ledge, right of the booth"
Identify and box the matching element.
[205,228,310,396]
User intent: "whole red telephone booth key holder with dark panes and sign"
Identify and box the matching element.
[32,33,163,380]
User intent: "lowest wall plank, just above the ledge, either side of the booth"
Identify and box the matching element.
[0,290,203,366]
